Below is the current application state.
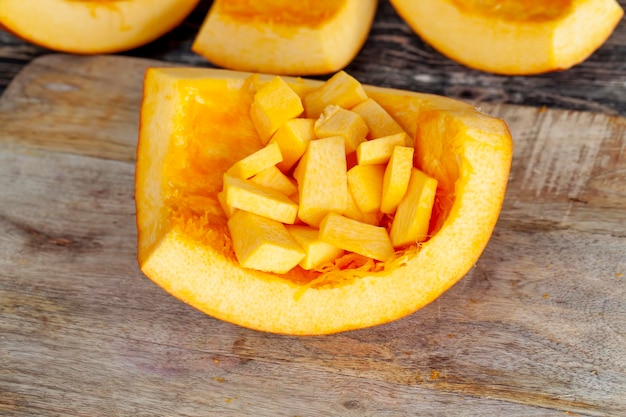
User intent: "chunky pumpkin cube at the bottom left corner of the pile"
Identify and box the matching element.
[228,210,305,274]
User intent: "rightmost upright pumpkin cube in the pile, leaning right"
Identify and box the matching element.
[389,168,437,248]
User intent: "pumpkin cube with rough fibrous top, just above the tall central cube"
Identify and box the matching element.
[315,104,368,154]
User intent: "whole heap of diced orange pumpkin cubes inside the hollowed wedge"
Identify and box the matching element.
[218,71,437,274]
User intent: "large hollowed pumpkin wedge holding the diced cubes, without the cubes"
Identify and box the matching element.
[136,68,512,335]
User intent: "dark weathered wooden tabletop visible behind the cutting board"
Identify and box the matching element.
[0,0,626,116]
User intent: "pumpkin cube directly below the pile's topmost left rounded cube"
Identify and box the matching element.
[270,118,316,172]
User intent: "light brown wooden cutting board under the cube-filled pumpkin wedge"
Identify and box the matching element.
[0,55,626,416]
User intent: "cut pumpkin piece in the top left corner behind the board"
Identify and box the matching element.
[0,0,199,54]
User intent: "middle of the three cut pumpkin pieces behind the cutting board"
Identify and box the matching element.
[192,0,378,75]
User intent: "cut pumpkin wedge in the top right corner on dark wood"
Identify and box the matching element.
[391,0,624,75]
